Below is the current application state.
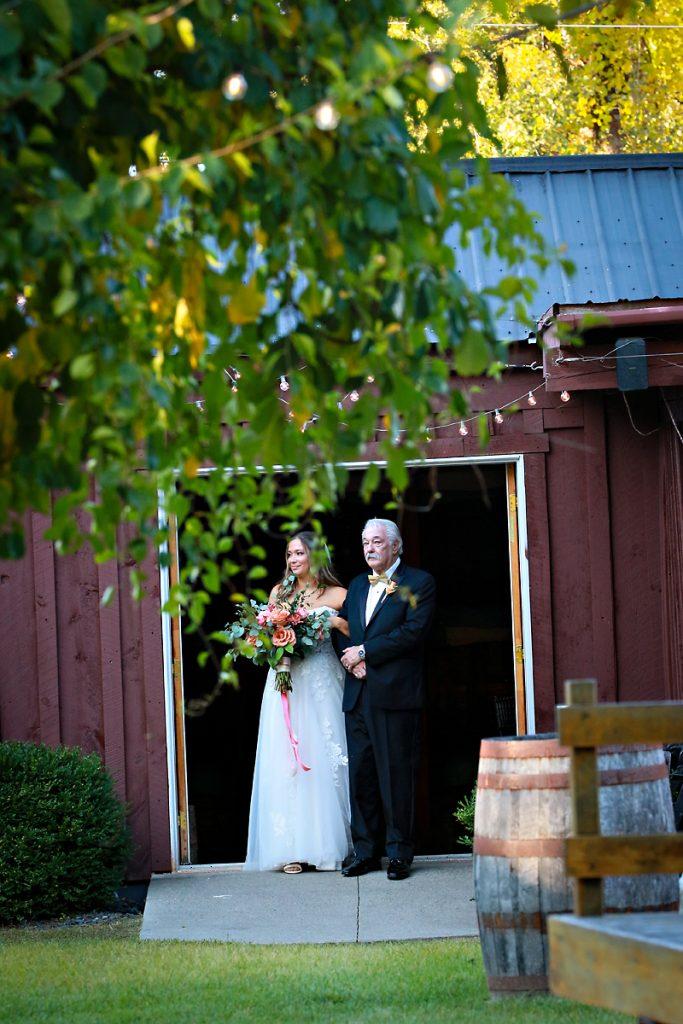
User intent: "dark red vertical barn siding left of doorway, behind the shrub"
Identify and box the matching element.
[0,514,171,879]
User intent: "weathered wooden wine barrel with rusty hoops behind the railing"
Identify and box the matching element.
[474,734,678,995]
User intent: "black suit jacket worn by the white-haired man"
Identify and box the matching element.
[335,562,436,711]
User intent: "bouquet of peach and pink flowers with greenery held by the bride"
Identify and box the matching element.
[225,577,330,693]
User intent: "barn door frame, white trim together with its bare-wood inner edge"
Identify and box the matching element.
[159,454,536,871]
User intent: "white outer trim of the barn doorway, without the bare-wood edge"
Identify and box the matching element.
[159,455,536,871]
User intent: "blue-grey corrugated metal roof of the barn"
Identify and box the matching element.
[446,154,683,339]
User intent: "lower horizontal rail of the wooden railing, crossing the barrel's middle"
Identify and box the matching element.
[566,833,683,880]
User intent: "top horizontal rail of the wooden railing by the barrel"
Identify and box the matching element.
[557,700,683,746]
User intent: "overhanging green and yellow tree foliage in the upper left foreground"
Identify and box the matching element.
[0,0,548,647]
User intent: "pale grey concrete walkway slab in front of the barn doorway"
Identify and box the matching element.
[140,857,477,944]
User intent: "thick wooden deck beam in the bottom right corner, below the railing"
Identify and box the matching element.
[548,912,683,1024]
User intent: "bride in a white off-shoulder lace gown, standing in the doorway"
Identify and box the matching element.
[244,531,351,873]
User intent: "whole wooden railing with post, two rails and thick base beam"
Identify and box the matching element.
[548,680,683,1024]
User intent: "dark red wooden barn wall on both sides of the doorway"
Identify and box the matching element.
[0,380,683,879]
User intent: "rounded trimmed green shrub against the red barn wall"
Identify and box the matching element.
[0,742,130,924]
